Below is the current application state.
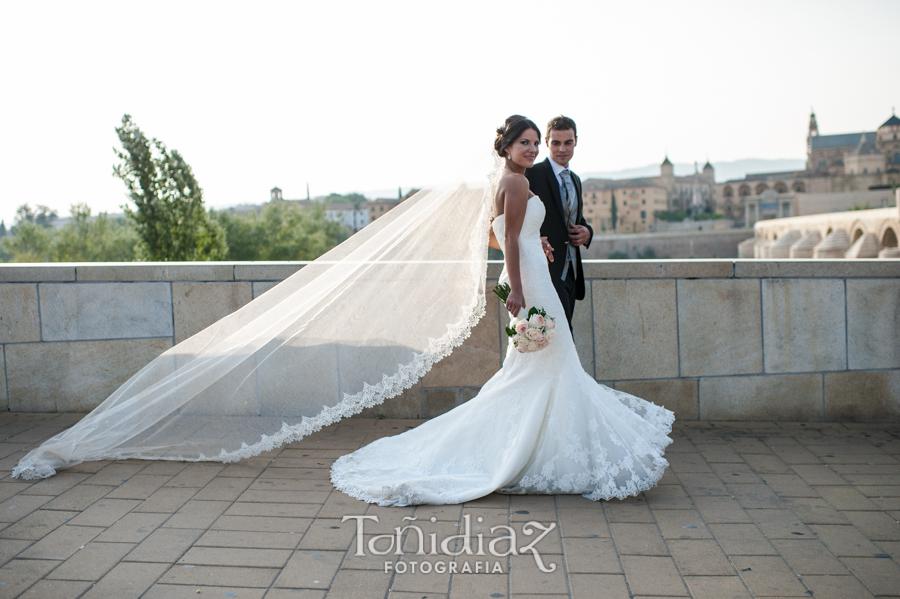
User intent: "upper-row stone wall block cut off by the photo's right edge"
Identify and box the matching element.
[847,278,900,370]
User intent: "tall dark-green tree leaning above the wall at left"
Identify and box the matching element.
[113,114,227,261]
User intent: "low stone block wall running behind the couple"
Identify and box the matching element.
[0,259,900,421]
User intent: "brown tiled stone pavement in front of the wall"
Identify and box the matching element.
[0,413,900,599]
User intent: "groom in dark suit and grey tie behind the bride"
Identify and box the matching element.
[525,116,594,331]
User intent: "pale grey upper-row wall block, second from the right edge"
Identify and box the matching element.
[762,279,847,373]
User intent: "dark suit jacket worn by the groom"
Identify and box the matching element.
[525,158,594,299]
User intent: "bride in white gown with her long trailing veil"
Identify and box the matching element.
[13,117,674,505]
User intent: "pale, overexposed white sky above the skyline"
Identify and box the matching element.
[0,0,900,225]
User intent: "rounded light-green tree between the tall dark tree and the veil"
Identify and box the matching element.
[216,202,348,260]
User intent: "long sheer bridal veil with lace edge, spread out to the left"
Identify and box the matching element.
[13,157,498,479]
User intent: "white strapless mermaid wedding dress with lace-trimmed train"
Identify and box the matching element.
[331,196,675,506]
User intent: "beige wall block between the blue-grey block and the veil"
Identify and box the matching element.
[172,283,253,343]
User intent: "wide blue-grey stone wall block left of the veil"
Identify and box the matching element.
[38,283,172,341]
